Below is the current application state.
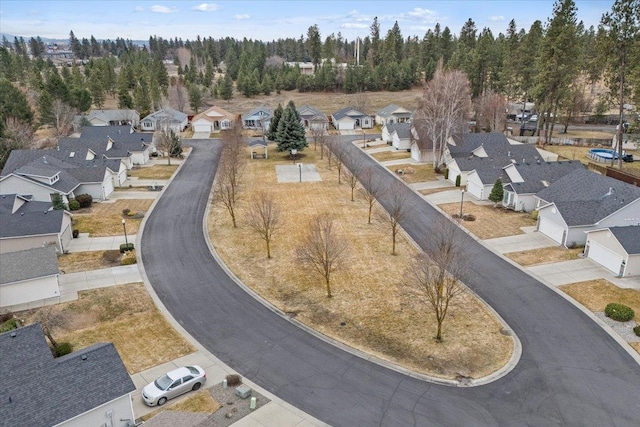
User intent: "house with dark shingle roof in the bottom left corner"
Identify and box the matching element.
[0,323,136,427]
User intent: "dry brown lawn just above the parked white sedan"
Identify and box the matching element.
[17,283,195,374]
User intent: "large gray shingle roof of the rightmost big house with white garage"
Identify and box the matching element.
[536,169,640,226]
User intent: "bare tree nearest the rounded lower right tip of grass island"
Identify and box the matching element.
[402,218,468,342]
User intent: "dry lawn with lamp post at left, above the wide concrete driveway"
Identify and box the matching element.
[73,199,153,237]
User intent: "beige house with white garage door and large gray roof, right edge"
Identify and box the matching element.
[536,169,640,246]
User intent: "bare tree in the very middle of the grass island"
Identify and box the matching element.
[297,214,348,298]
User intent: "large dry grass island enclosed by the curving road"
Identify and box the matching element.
[208,145,513,378]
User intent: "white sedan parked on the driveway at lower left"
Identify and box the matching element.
[142,365,207,406]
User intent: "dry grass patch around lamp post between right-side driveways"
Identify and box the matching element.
[439,202,536,240]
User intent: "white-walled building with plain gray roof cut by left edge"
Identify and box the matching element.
[0,246,60,310]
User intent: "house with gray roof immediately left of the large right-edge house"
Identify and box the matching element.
[502,160,584,212]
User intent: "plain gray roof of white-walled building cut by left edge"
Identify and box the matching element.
[0,246,59,285]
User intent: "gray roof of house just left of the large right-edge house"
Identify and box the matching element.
[509,160,584,194]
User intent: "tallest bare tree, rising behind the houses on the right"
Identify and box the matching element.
[414,63,471,167]
